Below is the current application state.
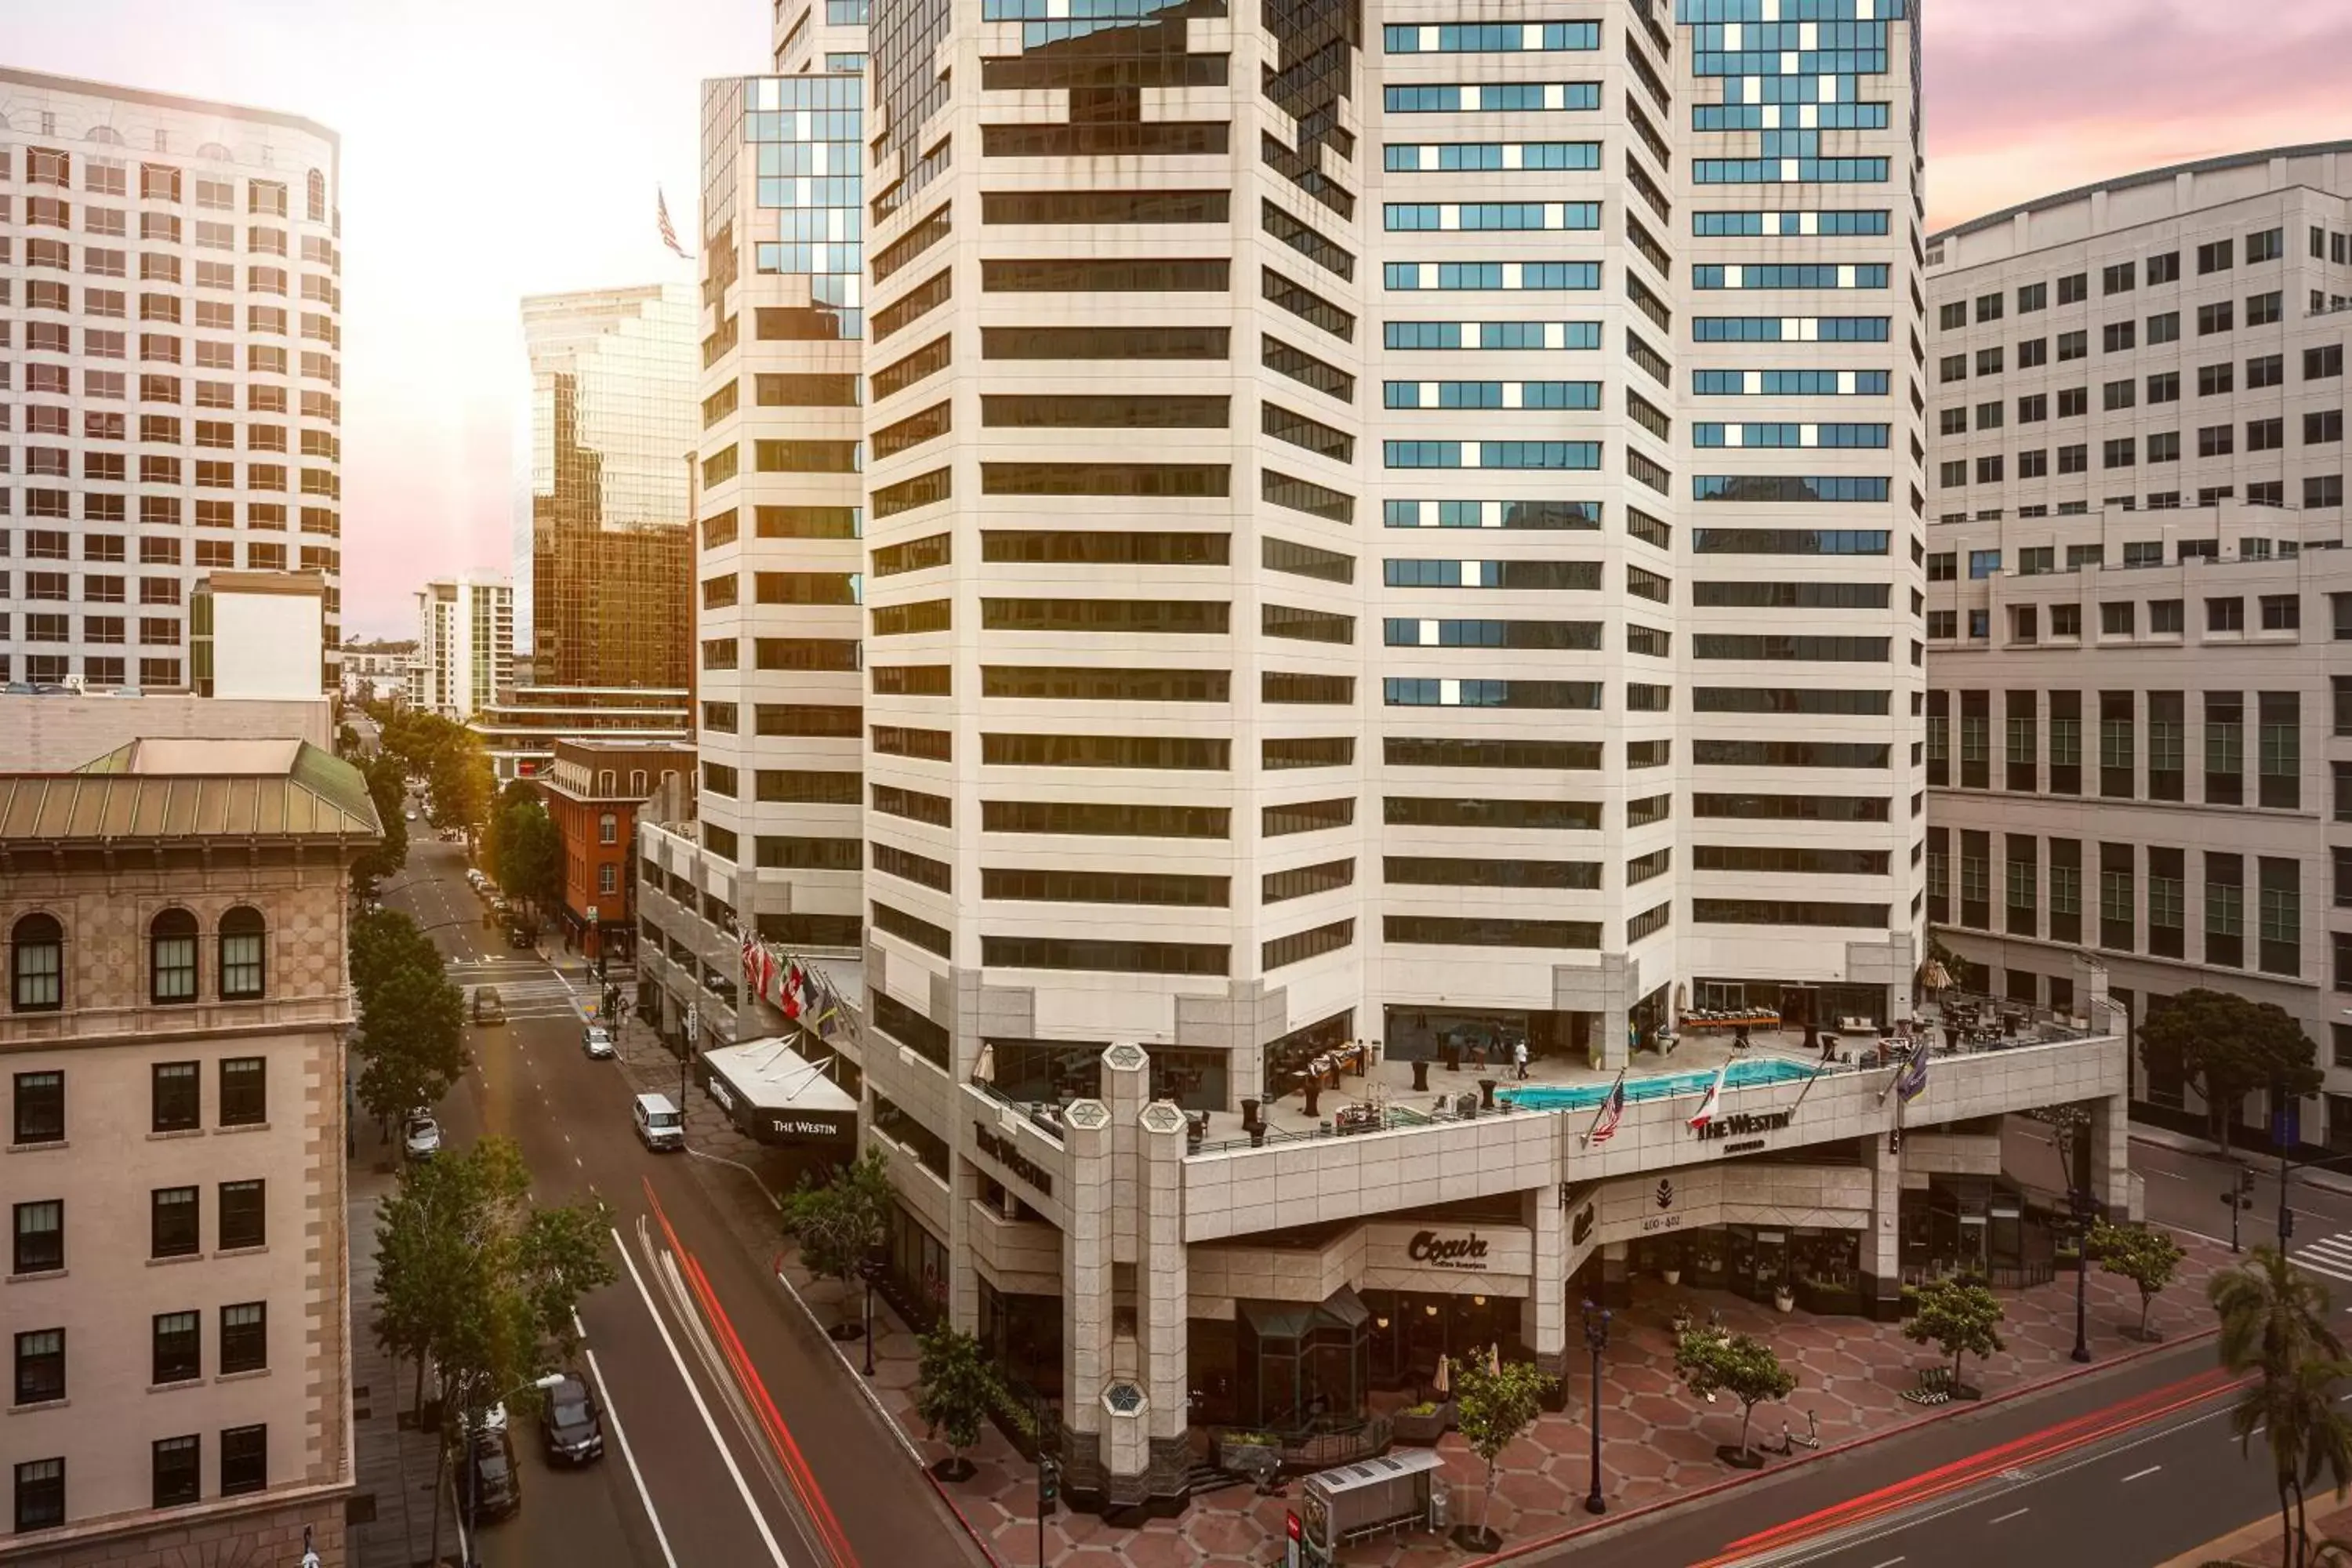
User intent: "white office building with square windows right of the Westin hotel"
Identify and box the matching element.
[1926,143,2352,1147]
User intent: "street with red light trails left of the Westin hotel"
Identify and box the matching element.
[383,822,978,1568]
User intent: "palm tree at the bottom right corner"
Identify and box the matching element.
[2206,1246,2352,1568]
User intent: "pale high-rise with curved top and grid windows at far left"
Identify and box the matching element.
[0,71,343,689]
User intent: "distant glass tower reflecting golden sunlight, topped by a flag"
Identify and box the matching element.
[522,285,696,691]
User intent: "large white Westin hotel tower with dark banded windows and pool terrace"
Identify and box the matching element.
[637,0,2129,1507]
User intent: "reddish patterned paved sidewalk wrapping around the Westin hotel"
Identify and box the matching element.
[621,1001,2230,1568]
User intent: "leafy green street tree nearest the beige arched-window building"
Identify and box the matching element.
[376,1138,616,1561]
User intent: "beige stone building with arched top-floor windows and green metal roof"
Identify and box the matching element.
[0,741,376,1568]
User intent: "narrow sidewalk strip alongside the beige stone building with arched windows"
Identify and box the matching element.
[348,1121,456,1568]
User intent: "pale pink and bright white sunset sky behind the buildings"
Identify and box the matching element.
[13,0,2352,635]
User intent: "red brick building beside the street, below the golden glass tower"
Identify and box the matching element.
[536,741,694,961]
